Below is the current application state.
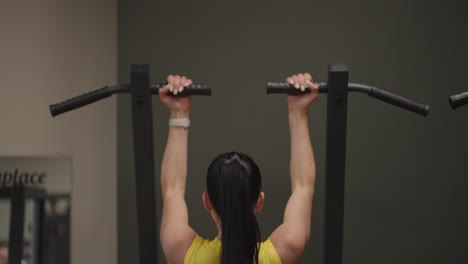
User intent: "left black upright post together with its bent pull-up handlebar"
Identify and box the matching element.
[49,64,212,264]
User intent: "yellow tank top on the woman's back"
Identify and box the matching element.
[184,235,281,264]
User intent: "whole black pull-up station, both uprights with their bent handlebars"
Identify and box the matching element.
[50,64,429,264]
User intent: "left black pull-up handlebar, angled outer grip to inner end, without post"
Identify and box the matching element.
[49,83,211,116]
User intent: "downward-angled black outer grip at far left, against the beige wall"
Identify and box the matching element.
[49,86,112,116]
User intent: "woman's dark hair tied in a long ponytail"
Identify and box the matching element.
[206,152,262,264]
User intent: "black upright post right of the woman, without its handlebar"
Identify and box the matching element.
[324,64,348,264]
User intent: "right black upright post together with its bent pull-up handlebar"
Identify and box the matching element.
[267,64,430,264]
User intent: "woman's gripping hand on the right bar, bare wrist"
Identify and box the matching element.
[286,73,319,112]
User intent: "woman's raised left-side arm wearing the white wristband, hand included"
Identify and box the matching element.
[160,75,196,263]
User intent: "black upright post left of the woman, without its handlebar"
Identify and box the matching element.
[130,65,158,264]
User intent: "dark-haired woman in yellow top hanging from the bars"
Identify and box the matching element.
[159,73,318,264]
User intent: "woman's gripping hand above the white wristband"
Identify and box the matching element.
[159,75,192,118]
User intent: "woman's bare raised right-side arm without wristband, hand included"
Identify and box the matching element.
[270,73,318,264]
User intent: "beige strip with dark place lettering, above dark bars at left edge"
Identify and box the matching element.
[0,156,72,193]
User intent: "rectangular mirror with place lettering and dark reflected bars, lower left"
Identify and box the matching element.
[0,156,71,264]
